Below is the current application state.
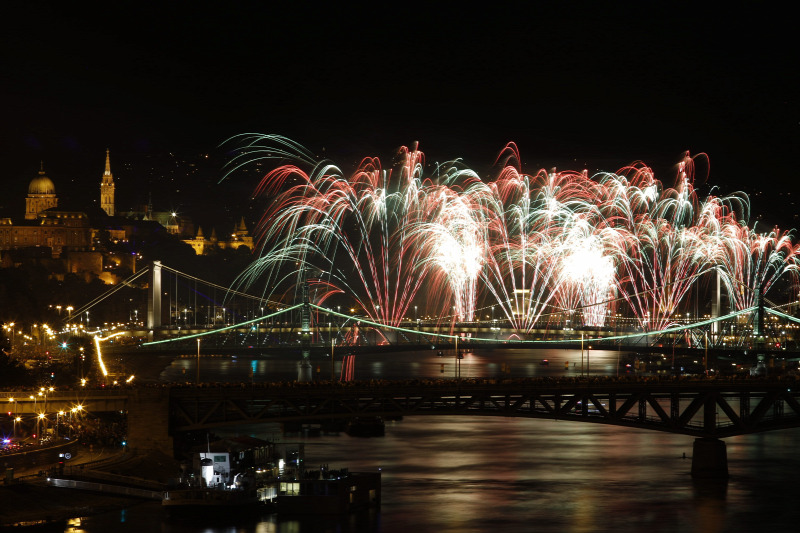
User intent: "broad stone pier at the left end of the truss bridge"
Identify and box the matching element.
[127,388,175,457]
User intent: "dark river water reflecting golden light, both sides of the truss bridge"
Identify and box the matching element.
[70,350,800,533]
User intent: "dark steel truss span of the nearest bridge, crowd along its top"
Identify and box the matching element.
[169,379,800,439]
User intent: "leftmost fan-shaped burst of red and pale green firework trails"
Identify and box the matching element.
[228,139,427,325]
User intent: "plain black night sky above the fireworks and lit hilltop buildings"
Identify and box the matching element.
[0,2,800,216]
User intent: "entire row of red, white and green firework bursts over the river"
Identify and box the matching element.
[220,134,798,333]
